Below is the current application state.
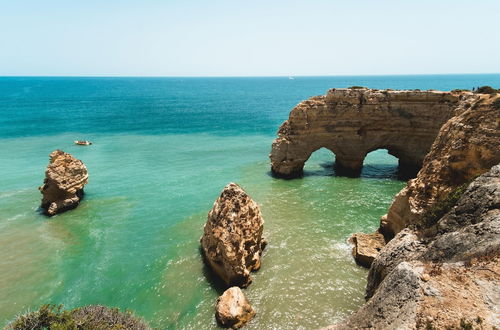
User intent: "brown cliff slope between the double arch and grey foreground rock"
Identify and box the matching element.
[380,95,500,237]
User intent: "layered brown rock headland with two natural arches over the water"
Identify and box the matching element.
[270,88,479,177]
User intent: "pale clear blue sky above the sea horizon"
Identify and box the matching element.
[0,0,500,76]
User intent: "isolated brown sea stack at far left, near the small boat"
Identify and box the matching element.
[39,150,89,216]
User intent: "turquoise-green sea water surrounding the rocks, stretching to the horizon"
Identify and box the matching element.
[0,75,500,329]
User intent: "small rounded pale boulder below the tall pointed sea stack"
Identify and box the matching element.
[215,286,255,329]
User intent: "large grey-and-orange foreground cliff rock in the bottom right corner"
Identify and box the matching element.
[329,165,500,329]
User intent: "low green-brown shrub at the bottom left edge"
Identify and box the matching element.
[5,305,149,330]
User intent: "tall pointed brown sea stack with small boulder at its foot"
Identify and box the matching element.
[201,183,265,287]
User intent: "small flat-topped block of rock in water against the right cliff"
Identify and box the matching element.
[349,232,385,268]
